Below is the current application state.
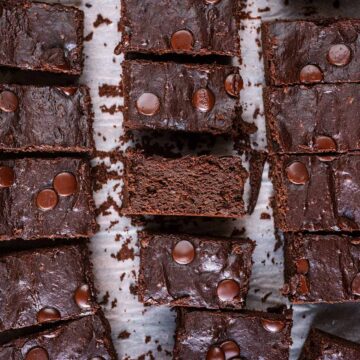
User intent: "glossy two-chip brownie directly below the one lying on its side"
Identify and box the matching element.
[139,233,255,309]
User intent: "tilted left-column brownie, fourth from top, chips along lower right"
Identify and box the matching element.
[0,243,97,341]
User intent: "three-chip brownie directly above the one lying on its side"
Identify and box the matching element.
[123,61,243,135]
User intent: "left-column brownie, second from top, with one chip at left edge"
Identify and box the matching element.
[0,85,94,154]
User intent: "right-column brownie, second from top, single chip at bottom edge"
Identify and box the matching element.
[264,84,360,153]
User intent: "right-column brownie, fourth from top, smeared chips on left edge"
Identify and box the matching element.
[284,233,360,303]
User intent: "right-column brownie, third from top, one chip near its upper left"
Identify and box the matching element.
[271,154,360,231]
